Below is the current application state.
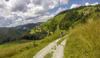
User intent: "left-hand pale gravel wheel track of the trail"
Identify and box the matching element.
[33,38,60,58]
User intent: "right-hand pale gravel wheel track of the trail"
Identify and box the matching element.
[52,39,66,58]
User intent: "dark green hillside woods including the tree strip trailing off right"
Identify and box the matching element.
[59,7,91,30]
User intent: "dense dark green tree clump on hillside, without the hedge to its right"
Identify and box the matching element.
[59,11,84,30]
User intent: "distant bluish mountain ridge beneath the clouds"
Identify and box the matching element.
[11,22,42,32]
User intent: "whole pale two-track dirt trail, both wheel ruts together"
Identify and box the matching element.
[33,35,68,58]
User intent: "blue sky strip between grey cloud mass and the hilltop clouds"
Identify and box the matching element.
[49,0,100,13]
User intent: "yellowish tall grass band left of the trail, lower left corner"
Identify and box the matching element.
[0,42,33,58]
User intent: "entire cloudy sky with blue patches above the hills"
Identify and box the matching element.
[0,0,100,27]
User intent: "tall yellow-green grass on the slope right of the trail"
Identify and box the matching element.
[64,20,100,58]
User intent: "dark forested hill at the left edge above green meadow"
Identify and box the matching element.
[0,28,23,44]
